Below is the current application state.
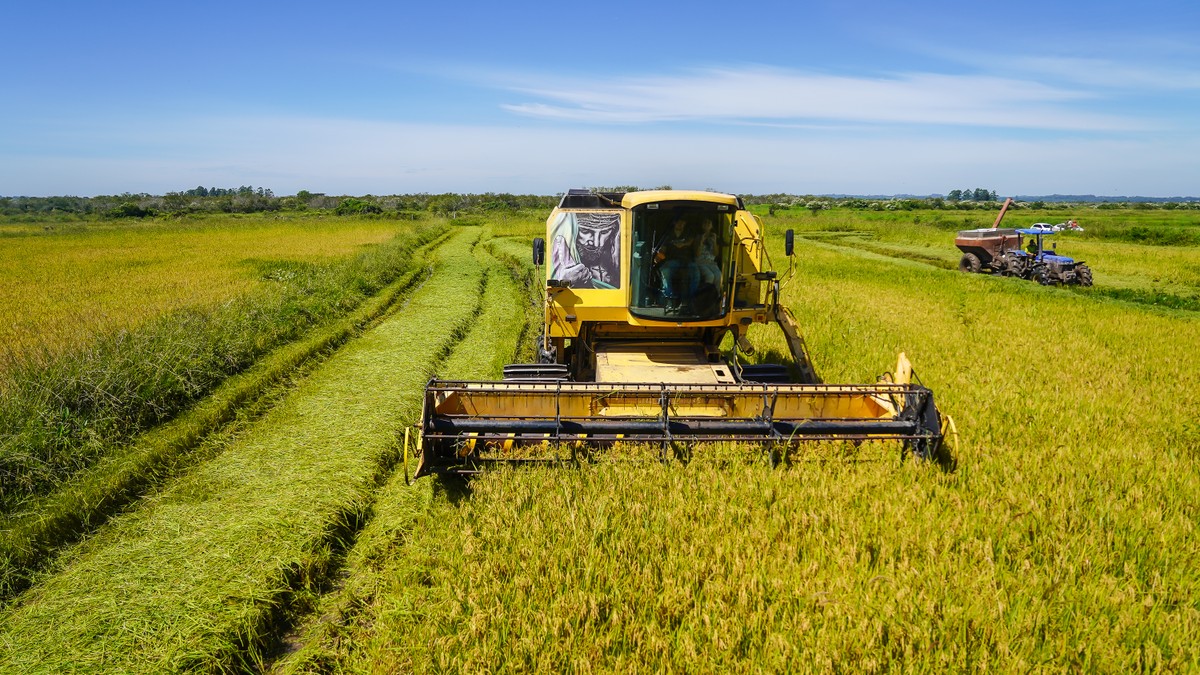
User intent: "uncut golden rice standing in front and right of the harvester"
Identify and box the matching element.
[274,224,1200,673]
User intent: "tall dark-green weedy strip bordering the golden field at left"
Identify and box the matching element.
[0,226,439,515]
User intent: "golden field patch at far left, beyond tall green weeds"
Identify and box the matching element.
[0,215,412,368]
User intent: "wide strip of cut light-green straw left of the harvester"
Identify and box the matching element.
[0,224,492,673]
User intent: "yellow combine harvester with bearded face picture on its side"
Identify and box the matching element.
[406,190,952,477]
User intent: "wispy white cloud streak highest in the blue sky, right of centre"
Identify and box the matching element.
[493,66,1146,131]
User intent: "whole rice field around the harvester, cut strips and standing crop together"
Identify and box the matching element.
[0,211,1200,673]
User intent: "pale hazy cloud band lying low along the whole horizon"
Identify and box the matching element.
[0,118,1200,196]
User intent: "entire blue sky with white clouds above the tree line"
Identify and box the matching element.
[0,0,1200,197]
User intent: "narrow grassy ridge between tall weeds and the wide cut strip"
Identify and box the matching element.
[0,229,451,599]
